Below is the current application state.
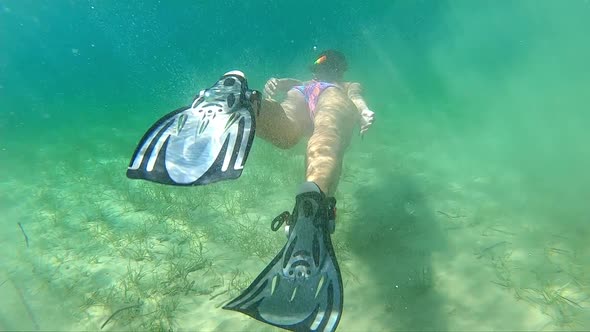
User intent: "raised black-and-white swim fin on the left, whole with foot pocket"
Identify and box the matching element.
[127,71,261,186]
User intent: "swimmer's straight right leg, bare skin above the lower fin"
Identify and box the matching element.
[306,88,358,197]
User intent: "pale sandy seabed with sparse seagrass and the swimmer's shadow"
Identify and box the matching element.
[0,120,590,331]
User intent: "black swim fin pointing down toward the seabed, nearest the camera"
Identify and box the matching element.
[223,182,343,331]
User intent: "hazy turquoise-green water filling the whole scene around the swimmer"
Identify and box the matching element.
[0,0,590,331]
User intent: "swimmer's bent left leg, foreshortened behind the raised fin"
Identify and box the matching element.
[256,90,311,149]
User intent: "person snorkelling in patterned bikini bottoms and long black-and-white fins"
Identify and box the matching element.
[127,50,374,331]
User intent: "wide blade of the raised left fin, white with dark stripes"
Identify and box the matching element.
[127,107,255,186]
